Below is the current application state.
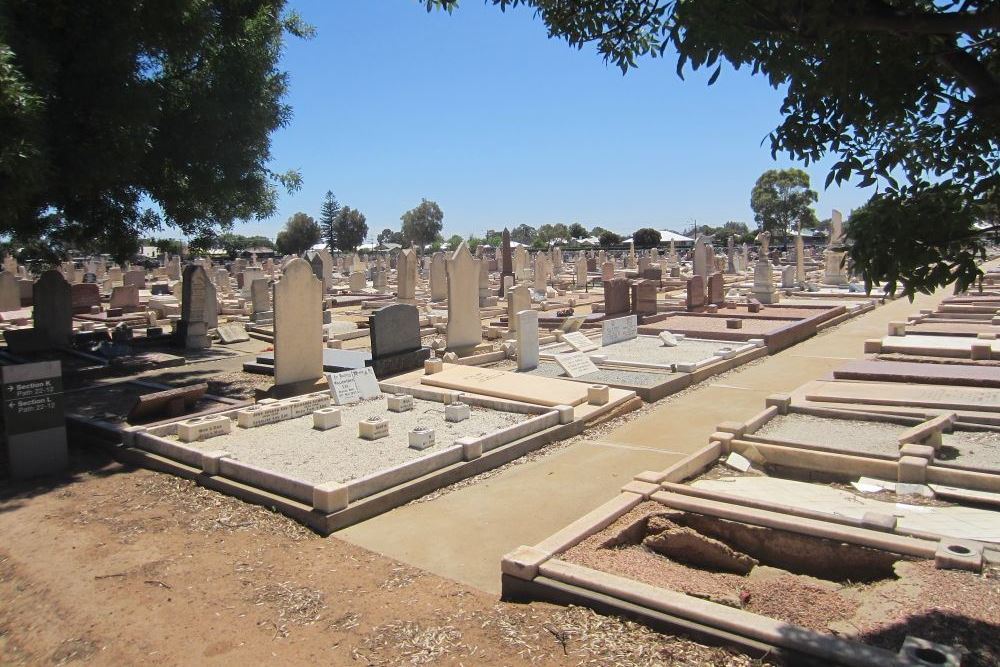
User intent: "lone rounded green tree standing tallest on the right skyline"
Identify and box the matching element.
[750,169,817,243]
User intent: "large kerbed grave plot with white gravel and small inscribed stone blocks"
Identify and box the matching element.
[121,369,578,533]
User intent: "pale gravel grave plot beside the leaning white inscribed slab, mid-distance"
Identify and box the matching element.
[539,334,763,373]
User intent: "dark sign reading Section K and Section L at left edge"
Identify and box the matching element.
[0,362,69,479]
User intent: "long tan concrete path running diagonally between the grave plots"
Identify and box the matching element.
[336,291,946,593]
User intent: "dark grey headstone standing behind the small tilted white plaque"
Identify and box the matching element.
[367,303,430,378]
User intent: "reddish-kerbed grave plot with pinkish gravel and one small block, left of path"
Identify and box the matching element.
[639,314,816,354]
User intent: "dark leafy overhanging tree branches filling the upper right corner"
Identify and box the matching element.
[425,0,1000,290]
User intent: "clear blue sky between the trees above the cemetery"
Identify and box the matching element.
[242,0,870,238]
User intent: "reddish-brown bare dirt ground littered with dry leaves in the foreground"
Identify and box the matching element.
[0,449,758,665]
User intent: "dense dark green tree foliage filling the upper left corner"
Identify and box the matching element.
[0,0,311,254]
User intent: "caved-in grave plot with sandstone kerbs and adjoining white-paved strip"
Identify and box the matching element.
[501,441,1000,665]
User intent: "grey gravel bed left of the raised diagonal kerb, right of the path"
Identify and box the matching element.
[753,414,907,457]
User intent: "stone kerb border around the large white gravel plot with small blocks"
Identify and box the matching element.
[78,383,584,534]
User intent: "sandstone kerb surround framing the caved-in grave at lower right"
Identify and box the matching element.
[501,472,956,666]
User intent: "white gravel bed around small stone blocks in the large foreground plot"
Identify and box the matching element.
[168,398,534,484]
